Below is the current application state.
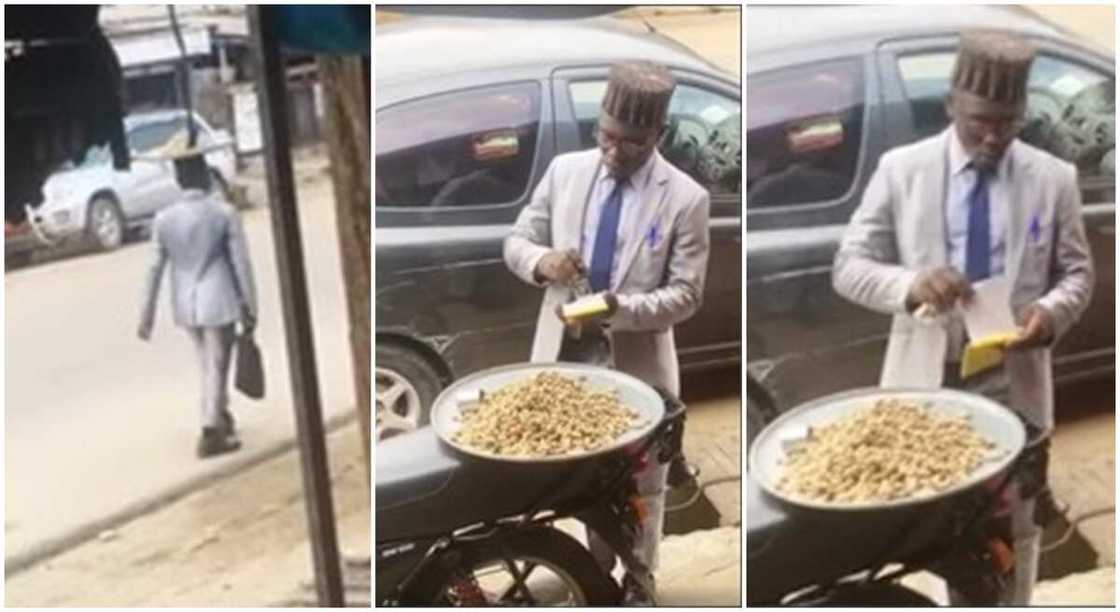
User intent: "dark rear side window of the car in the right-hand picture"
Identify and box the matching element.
[747,58,865,210]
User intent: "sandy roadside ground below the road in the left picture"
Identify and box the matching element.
[4,426,370,608]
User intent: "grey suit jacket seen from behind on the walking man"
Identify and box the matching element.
[140,191,256,327]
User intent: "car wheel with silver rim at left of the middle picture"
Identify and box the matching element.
[374,342,444,441]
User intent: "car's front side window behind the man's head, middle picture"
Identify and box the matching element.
[568,78,743,196]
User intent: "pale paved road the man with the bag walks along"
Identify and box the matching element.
[4,155,354,559]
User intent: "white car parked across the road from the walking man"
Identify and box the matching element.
[27,110,236,251]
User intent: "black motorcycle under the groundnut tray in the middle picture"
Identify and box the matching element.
[374,364,684,605]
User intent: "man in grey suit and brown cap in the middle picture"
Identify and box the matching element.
[504,62,709,597]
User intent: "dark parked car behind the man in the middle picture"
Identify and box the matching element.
[374,18,743,439]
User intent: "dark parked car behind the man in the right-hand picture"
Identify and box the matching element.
[745,6,1116,443]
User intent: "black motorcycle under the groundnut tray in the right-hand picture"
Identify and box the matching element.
[744,390,1038,606]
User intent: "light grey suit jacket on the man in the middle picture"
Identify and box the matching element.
[504,149,709,393]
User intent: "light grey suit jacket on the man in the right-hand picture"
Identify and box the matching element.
[832,127,1093,429]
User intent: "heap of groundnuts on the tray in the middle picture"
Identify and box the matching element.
[454,372,638,456]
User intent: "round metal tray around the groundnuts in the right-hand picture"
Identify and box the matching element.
[749,388,1027,511]
